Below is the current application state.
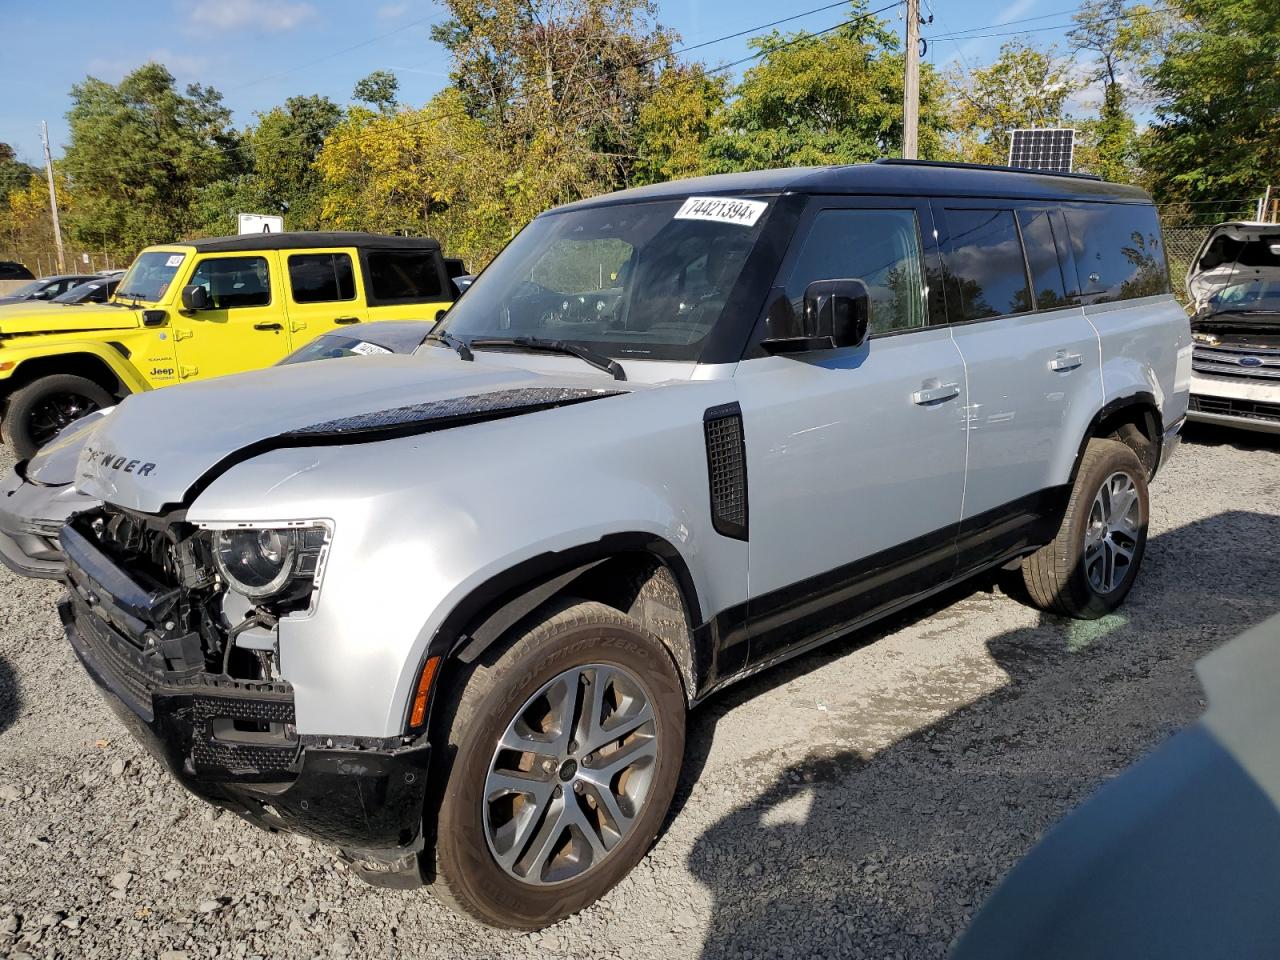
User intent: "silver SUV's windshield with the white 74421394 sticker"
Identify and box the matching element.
[443,197,768,360]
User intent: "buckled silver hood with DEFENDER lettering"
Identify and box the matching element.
[76,349,634,513]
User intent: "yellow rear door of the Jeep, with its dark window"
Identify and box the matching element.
[280,247,369,348]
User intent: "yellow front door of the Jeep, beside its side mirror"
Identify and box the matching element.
[172,251,289,380]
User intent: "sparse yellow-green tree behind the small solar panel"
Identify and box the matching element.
[948,38,1076,164]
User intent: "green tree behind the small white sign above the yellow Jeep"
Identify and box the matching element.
[198,96,344,234]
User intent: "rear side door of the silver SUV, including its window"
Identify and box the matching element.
[936,198,1102,568]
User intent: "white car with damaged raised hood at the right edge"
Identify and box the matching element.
[1187,223,1280,434]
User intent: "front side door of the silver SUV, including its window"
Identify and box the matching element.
[735,198,966,663]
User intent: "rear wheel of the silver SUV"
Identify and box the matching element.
[1023,439,1148,620]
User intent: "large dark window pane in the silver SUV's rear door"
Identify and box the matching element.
[943,209,1032,323]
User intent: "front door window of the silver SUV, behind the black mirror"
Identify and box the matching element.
[786,210,925,334]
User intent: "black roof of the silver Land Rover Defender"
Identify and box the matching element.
[559,160,1151,210]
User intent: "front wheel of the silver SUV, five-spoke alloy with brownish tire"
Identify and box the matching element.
[434,603,685,929]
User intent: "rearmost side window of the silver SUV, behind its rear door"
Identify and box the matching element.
[1065,204,1169,303]
